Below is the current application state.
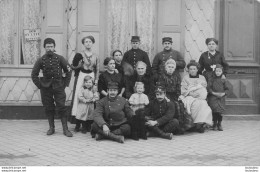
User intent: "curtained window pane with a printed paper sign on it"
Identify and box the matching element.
[20,0,41,65]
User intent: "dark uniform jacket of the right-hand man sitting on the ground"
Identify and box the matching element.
[145,99,175,126]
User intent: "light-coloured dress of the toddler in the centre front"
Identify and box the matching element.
[129,93,149,112]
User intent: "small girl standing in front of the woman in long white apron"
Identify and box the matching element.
[74,75,99,134]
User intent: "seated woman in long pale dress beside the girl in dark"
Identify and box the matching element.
[180,60,212,133]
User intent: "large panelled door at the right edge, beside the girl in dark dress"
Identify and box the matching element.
[220,0,260,114]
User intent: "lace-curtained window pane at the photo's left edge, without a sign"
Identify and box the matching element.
[0,0,15,64]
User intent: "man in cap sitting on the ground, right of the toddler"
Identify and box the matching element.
[145,82,181,140]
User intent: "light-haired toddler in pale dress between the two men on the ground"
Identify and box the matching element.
[129,82,149,112]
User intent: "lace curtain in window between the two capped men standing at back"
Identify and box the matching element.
[135,0,156,60]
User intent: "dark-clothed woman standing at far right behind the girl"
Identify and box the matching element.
[198,38,228,82]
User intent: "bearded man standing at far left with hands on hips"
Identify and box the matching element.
[31,38,72,137]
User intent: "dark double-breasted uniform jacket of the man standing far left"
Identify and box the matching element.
[31,53,71,89]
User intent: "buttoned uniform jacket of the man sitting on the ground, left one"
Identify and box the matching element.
[94,96,134,127]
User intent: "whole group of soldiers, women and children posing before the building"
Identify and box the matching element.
[32,36,228,143]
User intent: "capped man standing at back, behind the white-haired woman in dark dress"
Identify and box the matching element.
[152,37,186,76]
